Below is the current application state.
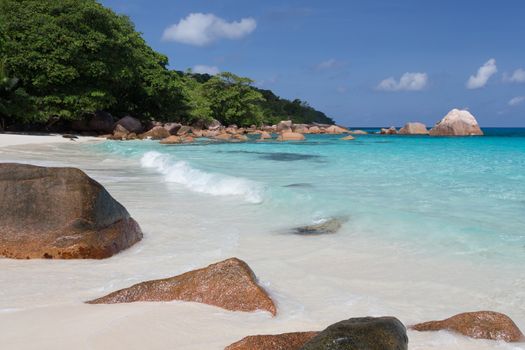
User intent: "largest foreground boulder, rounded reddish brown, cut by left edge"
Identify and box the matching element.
[0,163,142,259]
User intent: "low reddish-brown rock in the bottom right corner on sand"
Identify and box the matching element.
[410,311,524,342]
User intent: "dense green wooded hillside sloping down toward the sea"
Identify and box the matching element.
[0,0,333,129]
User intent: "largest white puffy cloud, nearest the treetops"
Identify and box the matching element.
[162,13,257,46]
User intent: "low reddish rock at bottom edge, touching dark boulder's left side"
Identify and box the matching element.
[224,332,318,350]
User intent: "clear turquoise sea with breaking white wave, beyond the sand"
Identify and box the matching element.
[90,129,525,264]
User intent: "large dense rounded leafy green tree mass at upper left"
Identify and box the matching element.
[0,0,187,124]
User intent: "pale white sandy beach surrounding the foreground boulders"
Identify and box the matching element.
[0,138,525,350]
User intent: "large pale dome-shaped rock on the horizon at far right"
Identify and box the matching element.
[430,109,483,136]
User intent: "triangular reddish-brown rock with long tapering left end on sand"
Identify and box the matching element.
[88,258,276,315]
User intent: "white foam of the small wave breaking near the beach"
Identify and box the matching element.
[141,151,263,203]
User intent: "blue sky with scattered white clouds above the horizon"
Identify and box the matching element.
[101,0,525,127]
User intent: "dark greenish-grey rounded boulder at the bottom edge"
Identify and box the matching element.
[301,317,408,350]
